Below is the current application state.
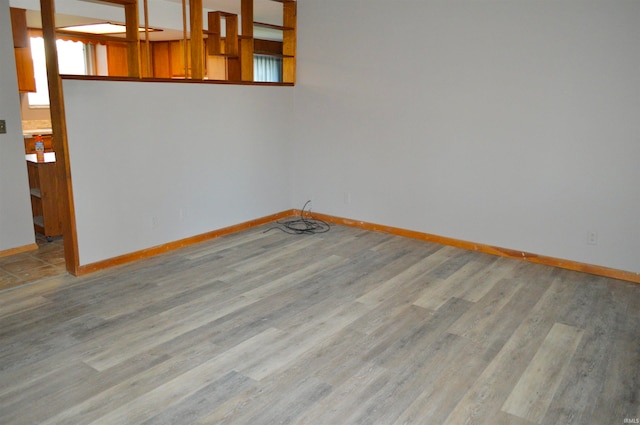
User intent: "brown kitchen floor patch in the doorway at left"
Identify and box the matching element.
[0,235,67,291]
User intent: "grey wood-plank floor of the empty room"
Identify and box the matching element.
[0,226,640,425]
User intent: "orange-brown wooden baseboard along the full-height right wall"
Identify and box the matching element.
[304,210,640,283]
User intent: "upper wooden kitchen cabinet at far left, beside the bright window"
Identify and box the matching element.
[10,7,36,93]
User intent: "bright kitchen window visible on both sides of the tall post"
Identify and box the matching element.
[27,37,93,107]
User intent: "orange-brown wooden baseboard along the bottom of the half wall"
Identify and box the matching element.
[77,210,294,276]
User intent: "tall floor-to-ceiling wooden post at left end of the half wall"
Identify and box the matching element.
[40,0,80,275]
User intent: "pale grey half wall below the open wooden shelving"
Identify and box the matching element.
[63,80,293,265]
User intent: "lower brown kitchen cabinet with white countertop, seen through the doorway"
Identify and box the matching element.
[26,152,62,240]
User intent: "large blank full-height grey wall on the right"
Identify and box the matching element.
[293,0,640,272]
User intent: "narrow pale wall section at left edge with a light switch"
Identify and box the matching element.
[0,0,35,251]
